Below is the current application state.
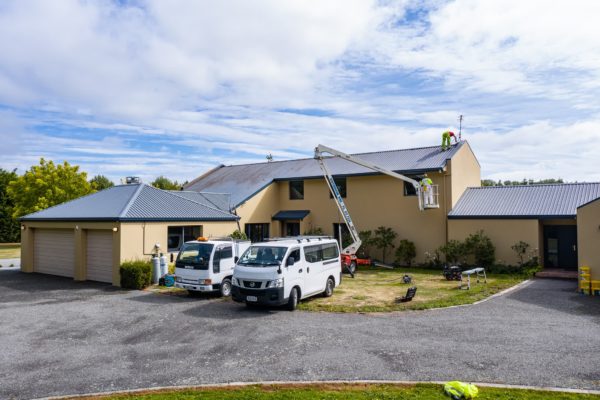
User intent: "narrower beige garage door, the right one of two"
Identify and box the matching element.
[86,230,113,283]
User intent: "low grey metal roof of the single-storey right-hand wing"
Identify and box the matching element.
[448,183,600,219]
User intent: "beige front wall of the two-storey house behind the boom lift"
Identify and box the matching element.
[237,173,447,262]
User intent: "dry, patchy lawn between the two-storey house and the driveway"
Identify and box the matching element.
[298,267,523,312]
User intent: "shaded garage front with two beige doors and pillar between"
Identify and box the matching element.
[23,224,118,283]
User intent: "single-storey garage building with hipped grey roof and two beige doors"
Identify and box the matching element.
[21,183,239,286]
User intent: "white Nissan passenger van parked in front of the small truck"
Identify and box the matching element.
[231,237,342,310]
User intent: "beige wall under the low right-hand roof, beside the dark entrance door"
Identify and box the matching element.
[448,219,541,264]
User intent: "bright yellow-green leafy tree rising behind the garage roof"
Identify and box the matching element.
[8,158,95,218]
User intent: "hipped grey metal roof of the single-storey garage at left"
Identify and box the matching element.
[21,184,238,221]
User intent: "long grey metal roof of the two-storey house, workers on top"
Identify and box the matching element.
[185,142,466,208]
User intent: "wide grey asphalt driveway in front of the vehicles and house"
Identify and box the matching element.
[0,269,600,399]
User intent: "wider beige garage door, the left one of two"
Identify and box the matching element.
[33,229,75,278]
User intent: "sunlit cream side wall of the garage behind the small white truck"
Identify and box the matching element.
[119,221,237,263]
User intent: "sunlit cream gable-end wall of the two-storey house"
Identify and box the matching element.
[447,143,481,209]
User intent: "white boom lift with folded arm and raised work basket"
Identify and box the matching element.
[315,144,440,278]
